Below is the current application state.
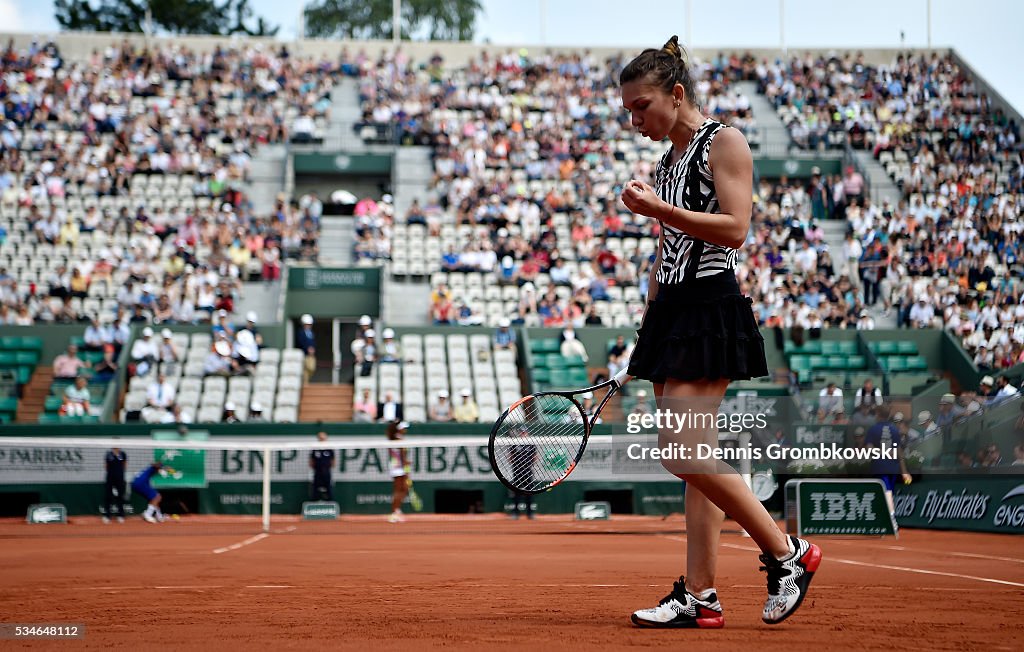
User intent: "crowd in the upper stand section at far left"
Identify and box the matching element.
[0,41,331,324]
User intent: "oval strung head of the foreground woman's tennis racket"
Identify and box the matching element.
[494,395,586,493]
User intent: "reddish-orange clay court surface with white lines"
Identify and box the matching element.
[0,516,1024,652]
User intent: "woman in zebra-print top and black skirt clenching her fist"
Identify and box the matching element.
[620,36,821,627]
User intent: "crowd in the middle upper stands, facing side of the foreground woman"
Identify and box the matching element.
[356,50,755,327]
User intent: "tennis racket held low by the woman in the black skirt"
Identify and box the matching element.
[487,370,632,494]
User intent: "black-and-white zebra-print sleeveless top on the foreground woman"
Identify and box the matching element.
[654,118,736,285]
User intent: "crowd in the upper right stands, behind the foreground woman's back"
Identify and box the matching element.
[758,54,1024,372]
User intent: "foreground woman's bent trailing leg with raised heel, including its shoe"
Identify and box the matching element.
[658,379,821,623]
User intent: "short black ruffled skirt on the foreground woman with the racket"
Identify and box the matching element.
[629,270,768,383]
